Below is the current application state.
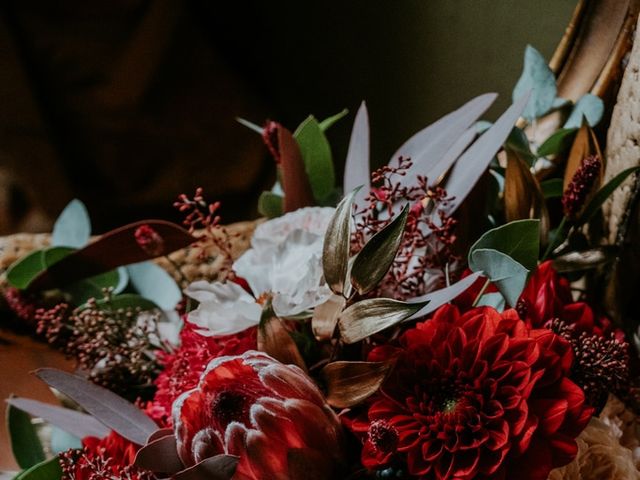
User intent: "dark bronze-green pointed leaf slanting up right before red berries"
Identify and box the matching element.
[351,204,409,295]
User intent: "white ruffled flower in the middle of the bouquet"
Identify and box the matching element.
[185,208,334,335]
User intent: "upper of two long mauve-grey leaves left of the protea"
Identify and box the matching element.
[36,368,158,445]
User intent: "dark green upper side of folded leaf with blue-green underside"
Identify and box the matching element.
[468,220,540,272]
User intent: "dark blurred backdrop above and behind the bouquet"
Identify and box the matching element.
[0,0,576,234]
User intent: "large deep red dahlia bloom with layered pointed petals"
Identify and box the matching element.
[349,305,592,480]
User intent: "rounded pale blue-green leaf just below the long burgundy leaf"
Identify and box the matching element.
[127,262,182,310]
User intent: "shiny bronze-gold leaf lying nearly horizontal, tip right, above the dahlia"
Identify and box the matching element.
[338,298,426,343]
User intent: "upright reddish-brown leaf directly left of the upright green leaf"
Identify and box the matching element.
[278,124,315,212]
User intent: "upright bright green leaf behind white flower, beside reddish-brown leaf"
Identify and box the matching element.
[293,115,335,202]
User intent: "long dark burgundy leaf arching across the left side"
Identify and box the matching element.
[28,220,196,290]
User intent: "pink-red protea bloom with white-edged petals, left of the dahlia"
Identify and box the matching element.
[173,351,343,480]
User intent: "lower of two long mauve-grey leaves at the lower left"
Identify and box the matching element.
[6,397,109,438]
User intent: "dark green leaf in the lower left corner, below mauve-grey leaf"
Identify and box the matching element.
[7,404,46,468]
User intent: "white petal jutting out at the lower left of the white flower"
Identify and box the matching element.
[184,280,262,336]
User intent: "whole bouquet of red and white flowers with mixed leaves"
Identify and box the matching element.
[4,48,640,480]
